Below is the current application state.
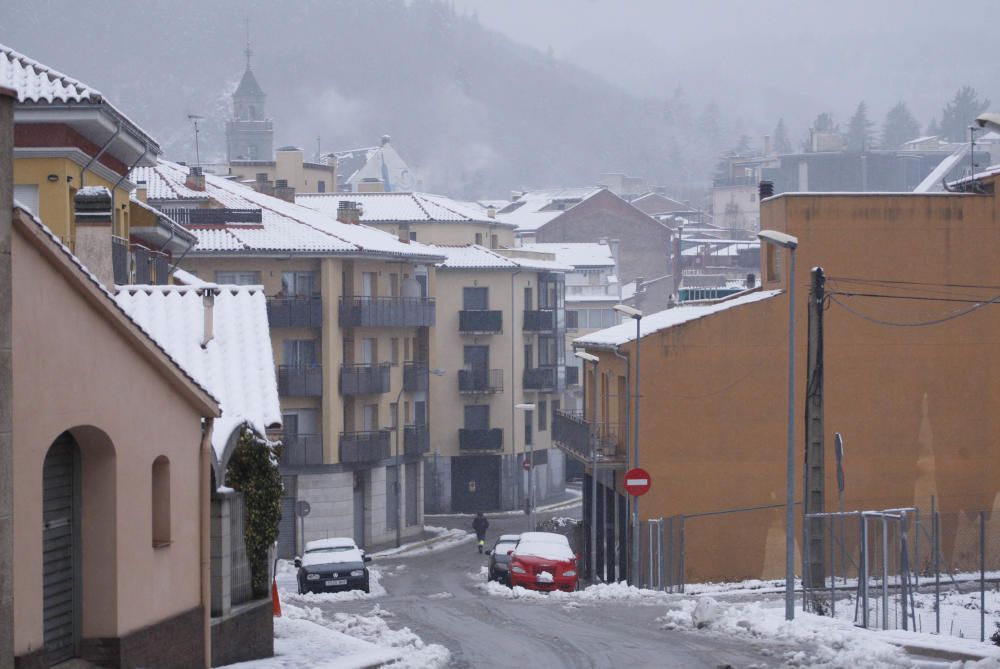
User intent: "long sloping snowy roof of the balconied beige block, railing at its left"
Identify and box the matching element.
[133,160,440,262]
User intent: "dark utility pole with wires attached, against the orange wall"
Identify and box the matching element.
[802,267,832,600]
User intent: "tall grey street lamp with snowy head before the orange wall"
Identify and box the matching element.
[757,230,799,620]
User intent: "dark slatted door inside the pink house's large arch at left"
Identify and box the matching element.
[42,432,81,664]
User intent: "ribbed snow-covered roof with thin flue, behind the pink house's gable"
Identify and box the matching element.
[115,285,281,472]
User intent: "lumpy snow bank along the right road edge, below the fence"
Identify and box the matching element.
[658,597,913,669]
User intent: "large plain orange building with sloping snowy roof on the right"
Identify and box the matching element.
[568,180,1000,582]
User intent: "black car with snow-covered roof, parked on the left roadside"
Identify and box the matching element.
[295,537,372,595]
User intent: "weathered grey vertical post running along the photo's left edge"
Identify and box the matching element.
[0,86,17,669]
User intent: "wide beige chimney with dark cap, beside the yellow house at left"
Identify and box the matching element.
[73,186,115,287]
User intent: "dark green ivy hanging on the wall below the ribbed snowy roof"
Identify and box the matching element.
[226,429,282,597]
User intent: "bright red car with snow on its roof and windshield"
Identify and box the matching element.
[509,532,580,592]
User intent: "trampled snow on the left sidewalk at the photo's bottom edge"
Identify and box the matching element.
[228,602,450,669]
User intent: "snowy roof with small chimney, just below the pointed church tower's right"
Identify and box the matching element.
[295,193,512,228]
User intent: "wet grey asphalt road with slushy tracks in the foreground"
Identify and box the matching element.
[318,506,796,669]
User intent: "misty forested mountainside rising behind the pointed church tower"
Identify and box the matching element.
[0,0,735,197]
